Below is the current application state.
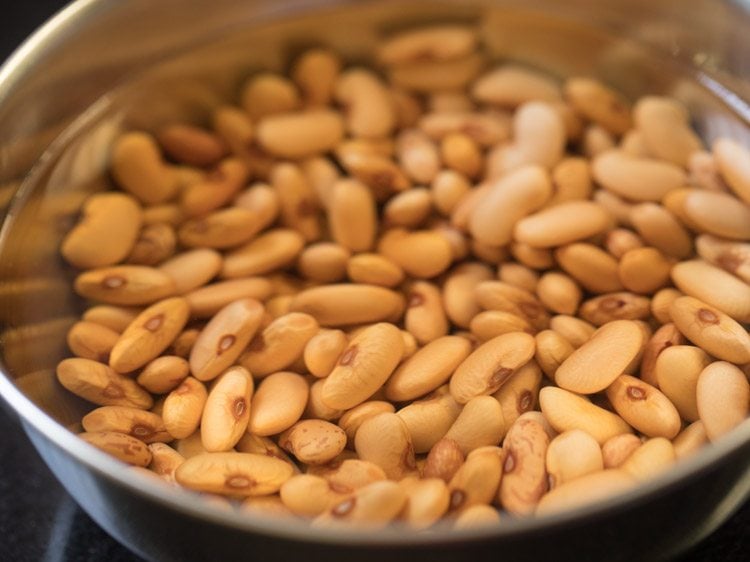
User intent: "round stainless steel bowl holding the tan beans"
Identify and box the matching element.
[0,0,750,561]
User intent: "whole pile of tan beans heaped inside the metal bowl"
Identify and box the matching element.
[57,26,750,529]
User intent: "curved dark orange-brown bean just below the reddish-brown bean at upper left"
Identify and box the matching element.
[180,158,250,217]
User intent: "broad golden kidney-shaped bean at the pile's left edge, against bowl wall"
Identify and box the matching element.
[60,193,143,269]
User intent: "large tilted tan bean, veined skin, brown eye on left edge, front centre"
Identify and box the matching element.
[323,323,404,410]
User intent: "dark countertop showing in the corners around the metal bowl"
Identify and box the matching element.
[0,0,750,562]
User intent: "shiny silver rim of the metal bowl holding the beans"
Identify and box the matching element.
[0,0,750,548]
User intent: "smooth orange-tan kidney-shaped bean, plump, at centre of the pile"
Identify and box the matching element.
[378,229,453,279]
